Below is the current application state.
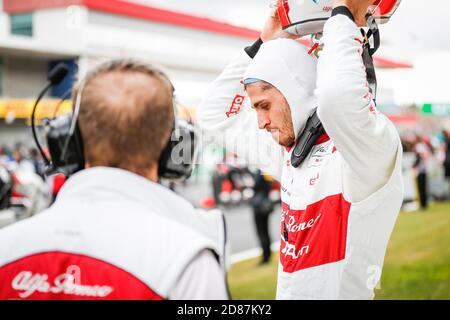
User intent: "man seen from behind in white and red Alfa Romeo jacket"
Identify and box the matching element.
[0,60,228,300]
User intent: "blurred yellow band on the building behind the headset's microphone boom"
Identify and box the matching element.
[0,99,72,120]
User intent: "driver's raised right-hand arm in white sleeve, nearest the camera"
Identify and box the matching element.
[317,0,400,201]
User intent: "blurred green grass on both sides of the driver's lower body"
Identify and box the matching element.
[228,203,450,300]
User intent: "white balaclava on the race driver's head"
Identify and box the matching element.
[243,39,317,139]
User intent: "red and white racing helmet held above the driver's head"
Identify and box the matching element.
[277,0,401,36]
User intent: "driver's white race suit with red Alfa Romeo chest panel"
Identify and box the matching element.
[198,15,403,299]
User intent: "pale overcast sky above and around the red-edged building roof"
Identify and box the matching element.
[130,0,450,104]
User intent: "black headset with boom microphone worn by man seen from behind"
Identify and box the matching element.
[31,60,198,180]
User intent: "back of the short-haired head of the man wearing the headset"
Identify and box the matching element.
[73,60,174,175]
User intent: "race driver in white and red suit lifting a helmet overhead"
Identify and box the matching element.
[199,0,403,299]
